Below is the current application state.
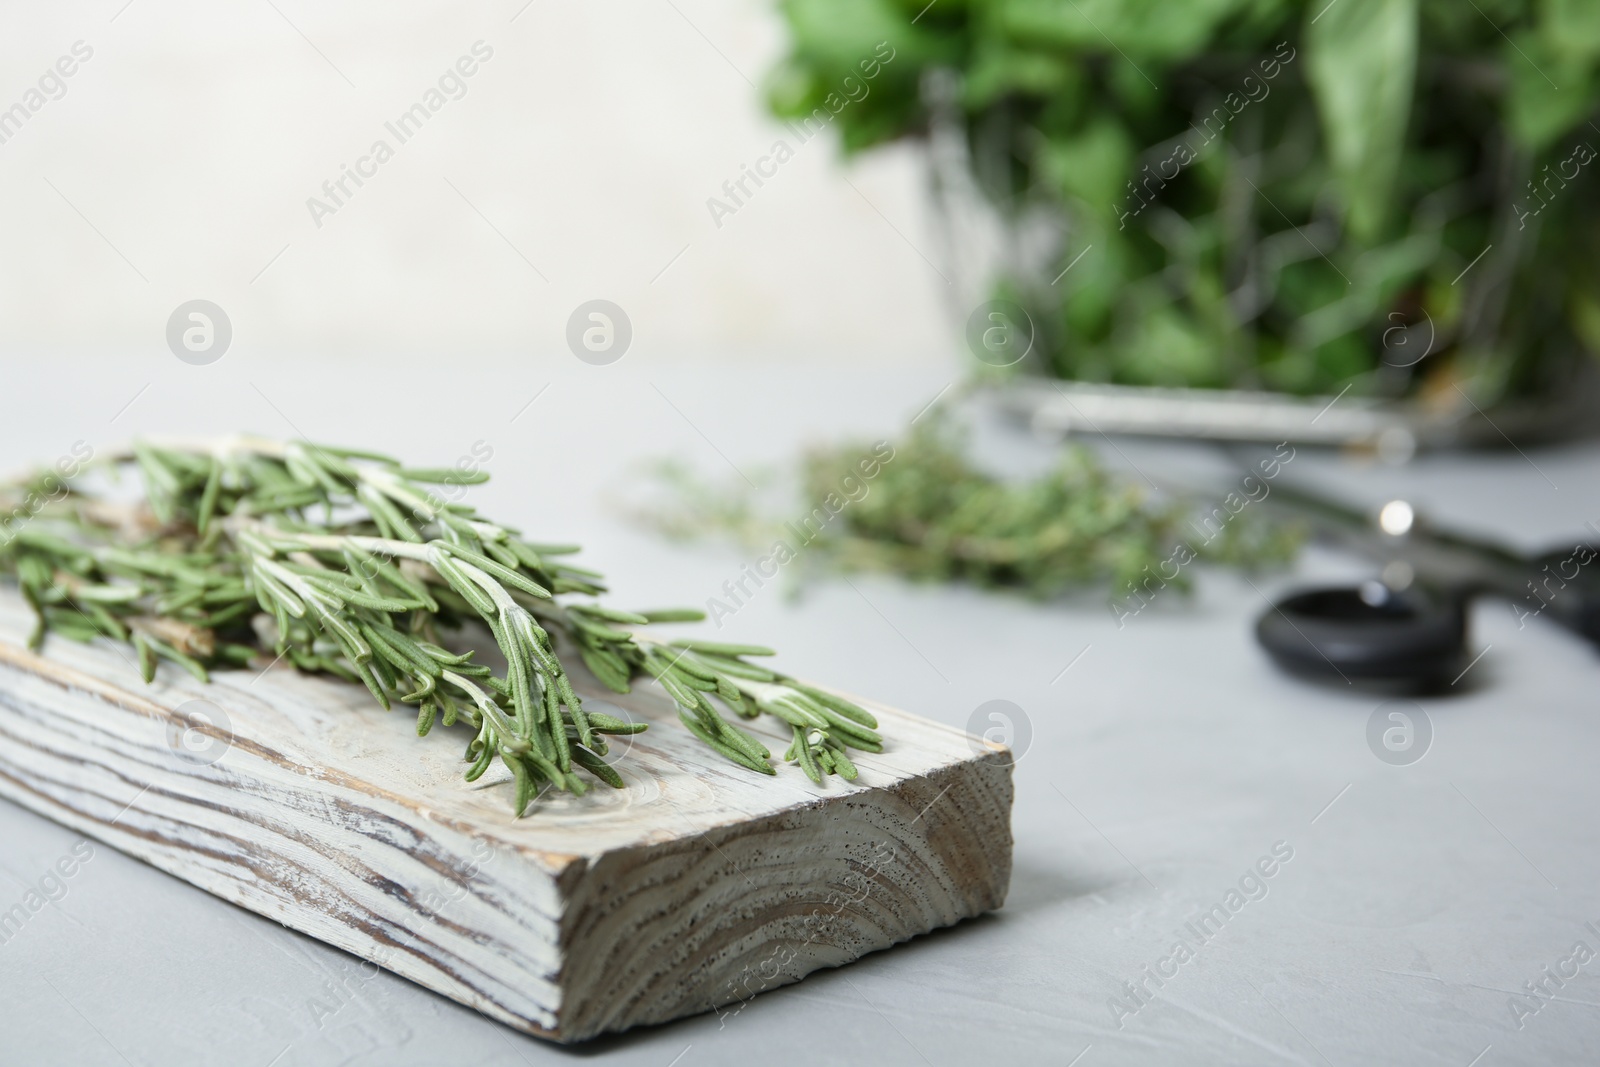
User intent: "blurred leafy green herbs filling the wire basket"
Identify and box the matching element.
[770,0,1600,402]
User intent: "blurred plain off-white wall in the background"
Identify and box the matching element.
[0,0,957,363]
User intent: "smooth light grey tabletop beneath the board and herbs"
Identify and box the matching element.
[0,347,1600,1067]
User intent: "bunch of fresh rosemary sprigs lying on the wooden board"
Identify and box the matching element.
[0,437,883,816]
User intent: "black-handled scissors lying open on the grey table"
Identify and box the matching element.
[1256,483,1600,688]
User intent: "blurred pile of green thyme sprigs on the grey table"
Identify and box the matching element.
[635,408,1304,597]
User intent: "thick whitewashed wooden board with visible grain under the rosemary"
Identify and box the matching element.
[0,589,1011,1041]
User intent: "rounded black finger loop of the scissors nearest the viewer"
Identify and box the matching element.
[1256,582,1467,685]
